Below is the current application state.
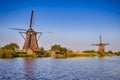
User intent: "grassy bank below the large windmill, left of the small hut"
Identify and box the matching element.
[0,49,50,58]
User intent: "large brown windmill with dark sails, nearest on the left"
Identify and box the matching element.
[10,10,51,53]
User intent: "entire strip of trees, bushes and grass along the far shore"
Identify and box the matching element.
[0,43,120,58]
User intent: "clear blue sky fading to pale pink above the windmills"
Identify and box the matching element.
[0,0,120,51]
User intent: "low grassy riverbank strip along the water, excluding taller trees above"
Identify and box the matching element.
[0,50,120,58]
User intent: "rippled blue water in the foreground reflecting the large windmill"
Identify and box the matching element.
[0,57,120,80]
